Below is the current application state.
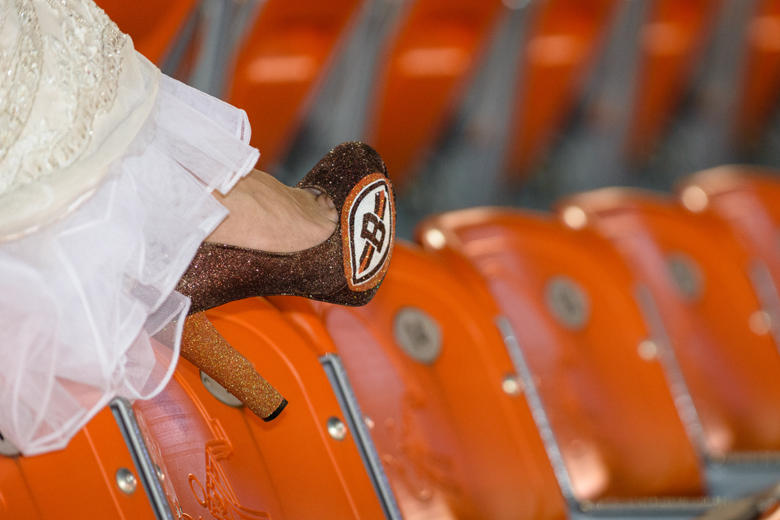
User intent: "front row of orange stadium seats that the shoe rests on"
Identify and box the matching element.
[0,167,780,520]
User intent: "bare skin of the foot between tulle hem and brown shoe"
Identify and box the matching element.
[206,170,339,253]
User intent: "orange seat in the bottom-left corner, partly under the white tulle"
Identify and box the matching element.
[0,408,156,520]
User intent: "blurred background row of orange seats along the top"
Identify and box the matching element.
[98,0,780,192]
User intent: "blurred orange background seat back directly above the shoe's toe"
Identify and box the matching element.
[368,0,502,189]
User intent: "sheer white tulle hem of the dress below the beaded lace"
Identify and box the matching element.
[0,70,259,455]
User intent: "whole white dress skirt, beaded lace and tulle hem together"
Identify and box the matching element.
[0,0,259,455]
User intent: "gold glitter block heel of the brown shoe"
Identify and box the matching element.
[181,312,287,421]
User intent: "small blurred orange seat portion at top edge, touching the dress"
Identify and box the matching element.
[96,0,197,66]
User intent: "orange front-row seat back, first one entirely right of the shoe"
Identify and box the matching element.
[417,209,704,501]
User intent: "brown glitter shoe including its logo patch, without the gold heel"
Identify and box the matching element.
[176,142,395,314]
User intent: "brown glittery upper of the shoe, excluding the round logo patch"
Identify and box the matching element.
[176,142,395,313]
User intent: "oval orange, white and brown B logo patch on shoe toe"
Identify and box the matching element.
[341,173,395,291]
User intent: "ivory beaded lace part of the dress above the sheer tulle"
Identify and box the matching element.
[0,0,126,195]
